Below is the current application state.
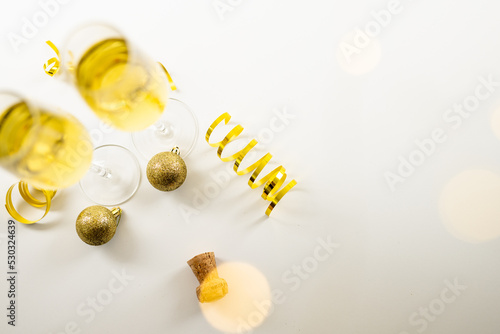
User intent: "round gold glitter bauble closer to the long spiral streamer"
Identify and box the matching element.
[146,152,187,191]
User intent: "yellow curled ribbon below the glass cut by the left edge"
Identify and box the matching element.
[5,181,57,224]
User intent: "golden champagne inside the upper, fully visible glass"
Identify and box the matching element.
[76,39,168,131]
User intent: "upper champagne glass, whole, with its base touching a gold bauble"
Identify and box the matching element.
[57,24,198,160]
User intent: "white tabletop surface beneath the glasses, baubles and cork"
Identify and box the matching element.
[0,0,500,334]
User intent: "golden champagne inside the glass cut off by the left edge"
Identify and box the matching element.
[0,102,93,189]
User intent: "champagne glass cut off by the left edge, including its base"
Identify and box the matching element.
[0,92,140,206]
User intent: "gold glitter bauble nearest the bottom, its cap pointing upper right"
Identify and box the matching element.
[76,205,121,246]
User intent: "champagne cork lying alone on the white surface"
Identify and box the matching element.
[187,252,228,303]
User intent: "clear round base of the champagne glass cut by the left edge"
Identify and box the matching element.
[80,145,141,206]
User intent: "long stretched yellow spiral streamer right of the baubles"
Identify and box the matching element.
[205,113,297,216]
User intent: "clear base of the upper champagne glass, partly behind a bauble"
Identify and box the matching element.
[132,98,199,161]
